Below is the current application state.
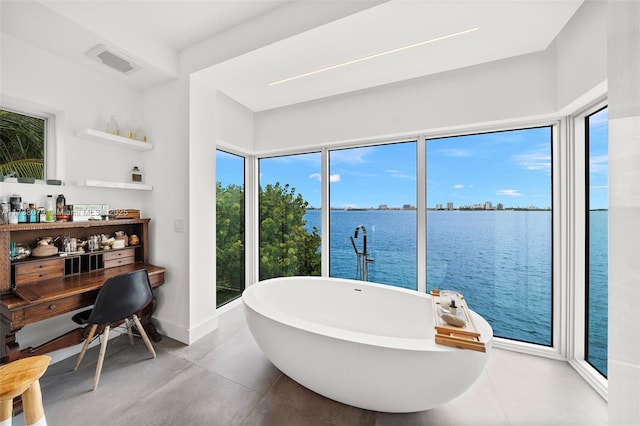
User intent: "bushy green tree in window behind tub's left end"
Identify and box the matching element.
[260,182,321,280]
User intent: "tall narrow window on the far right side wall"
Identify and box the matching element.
[585,108,609,377]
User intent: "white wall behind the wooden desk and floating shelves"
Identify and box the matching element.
[0,34,148,361]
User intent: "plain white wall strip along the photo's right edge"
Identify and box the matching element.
[608,1,640,425]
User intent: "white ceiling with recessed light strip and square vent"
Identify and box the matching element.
[1,0,583,111]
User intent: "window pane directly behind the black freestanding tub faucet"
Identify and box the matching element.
[329,141,417,290]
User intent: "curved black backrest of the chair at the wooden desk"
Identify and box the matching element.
[87,269,153,324]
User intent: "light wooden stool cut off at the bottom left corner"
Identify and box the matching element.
[0,355,51,426]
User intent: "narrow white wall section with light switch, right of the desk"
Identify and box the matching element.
[143,78,190,343]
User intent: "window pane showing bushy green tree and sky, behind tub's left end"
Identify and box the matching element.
[259,153,322,280]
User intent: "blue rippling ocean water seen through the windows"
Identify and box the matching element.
[306,210,607,368]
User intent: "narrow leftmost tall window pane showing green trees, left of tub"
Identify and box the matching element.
[216,150,245,306]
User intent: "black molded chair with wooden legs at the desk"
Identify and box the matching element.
[72,269,156,390]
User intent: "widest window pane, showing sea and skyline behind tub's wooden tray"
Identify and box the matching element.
[426,127,552,345]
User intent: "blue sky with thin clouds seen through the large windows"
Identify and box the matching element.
[217,116,608,208]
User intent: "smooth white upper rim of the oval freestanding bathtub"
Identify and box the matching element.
[242,276,493,355]
